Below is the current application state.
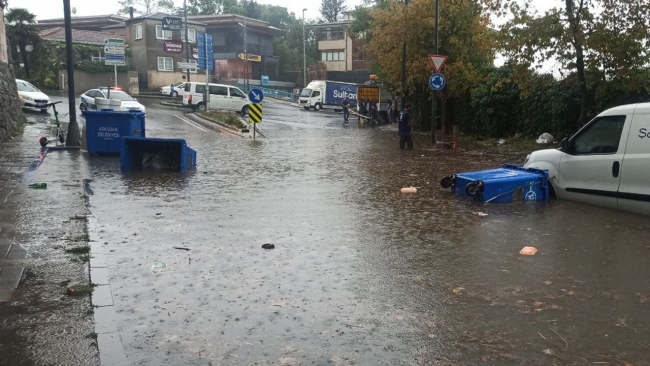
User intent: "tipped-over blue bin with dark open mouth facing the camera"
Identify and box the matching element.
[120,137,196,172]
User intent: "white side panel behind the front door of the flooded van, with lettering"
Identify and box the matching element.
[618,106,650,215]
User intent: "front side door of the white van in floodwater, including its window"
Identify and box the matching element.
[556,114,632,209]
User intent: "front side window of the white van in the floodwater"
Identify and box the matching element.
[573,116,625,155]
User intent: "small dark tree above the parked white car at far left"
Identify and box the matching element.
[5,8,40,79]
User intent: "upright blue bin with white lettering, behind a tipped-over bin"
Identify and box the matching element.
[82,110,145,155]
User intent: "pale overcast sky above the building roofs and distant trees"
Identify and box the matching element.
[16,0,362,19]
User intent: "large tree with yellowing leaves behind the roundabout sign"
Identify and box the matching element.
[366,0,495,127]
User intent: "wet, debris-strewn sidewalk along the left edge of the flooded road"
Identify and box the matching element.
[0,115,99,366]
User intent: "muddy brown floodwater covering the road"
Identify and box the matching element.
[90,128,650,365]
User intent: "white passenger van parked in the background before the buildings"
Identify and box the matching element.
[183,82,249,114]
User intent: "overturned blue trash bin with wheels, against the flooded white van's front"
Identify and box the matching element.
[440,164,549,203]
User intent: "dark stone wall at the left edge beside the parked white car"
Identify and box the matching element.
[0,62,25,141]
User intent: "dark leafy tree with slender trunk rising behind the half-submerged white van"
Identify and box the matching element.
[485,0,650,127]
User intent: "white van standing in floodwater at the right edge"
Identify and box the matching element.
[524,103,650,215]
